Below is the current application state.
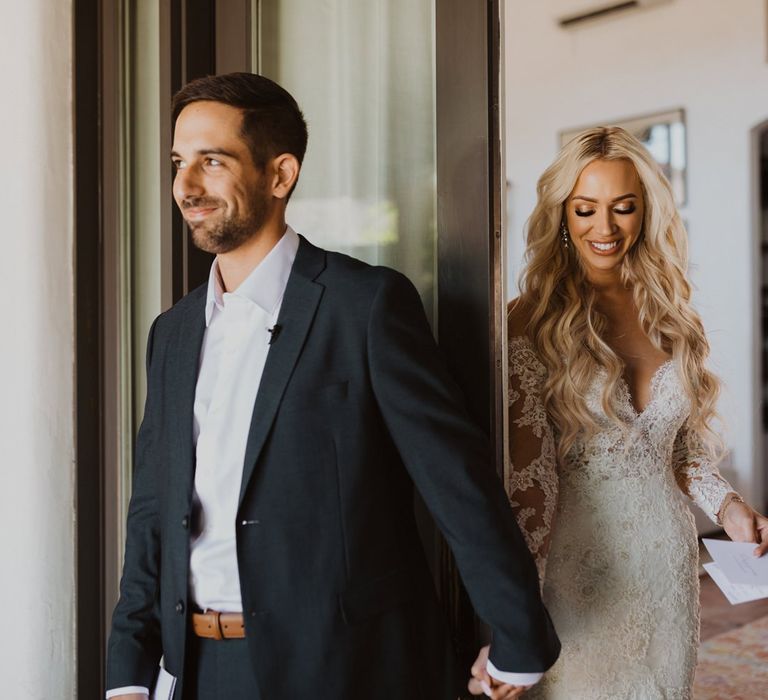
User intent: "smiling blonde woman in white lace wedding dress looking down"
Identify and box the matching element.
[492,128,768,700]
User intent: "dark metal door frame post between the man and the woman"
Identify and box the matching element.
[436,0,505,684]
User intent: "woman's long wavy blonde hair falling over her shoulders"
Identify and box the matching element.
[519,127,722,458]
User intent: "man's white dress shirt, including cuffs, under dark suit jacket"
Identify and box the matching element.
[106,226,542,698]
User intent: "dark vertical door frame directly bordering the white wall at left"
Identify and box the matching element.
[74,0,104,697]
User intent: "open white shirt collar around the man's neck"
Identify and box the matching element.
[205,226,299,327]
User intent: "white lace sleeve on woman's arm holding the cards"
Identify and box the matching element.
[672,425,733,525]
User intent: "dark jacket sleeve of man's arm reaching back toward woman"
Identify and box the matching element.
[368,270,560,673]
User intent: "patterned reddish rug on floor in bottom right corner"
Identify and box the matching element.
[693,616,768,700]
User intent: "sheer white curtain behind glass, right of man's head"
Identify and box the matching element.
[253,0,436,322]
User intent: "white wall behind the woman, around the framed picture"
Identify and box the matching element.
[504,0,768,502]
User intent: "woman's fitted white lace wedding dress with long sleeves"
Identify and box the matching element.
[507,337,732,700]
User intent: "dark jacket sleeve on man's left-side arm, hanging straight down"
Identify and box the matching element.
[107,319,162,688]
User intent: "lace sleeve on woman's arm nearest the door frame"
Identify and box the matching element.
[506,337,558,584]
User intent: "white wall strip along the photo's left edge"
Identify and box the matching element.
[0,0,75,700]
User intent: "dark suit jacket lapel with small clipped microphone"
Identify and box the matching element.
[240,236,325,502]
